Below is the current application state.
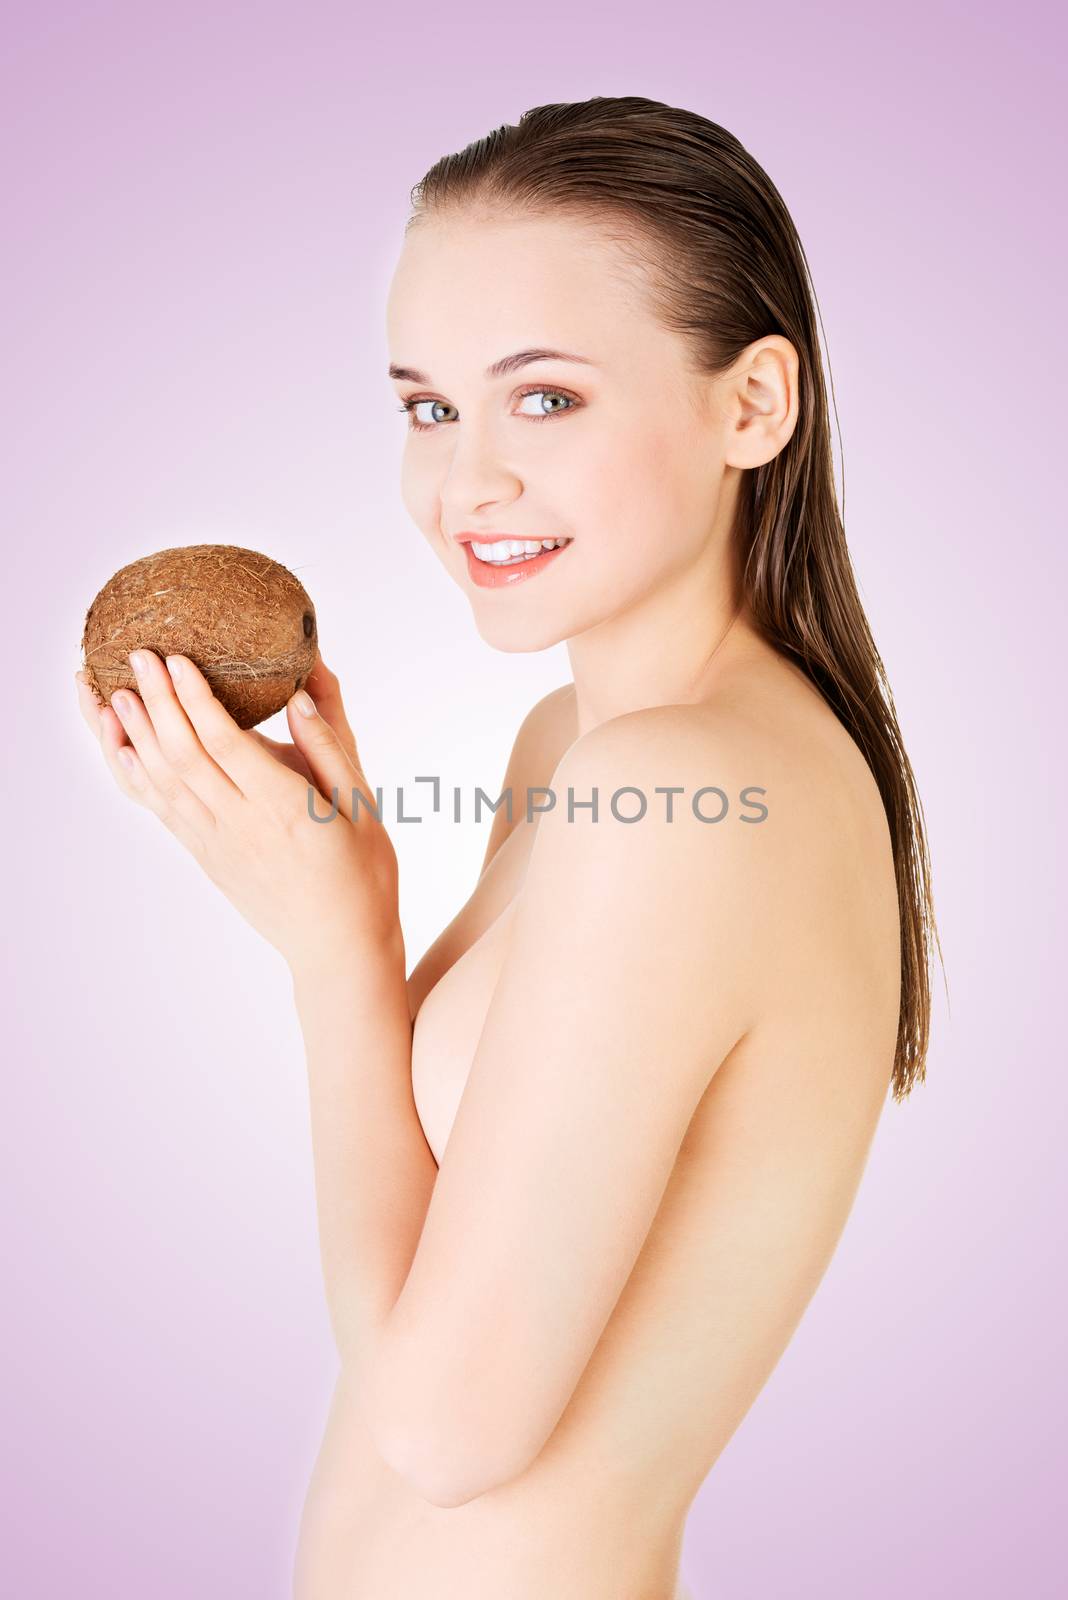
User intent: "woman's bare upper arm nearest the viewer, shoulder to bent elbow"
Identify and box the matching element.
[362,709,766,1504]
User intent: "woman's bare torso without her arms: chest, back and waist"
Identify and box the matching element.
[294,651,900,1600]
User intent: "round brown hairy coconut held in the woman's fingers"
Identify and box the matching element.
[82,544,318,728]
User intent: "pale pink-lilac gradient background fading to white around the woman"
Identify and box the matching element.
[0,3,1068,1600]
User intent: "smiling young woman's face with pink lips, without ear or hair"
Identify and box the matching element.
[387,218,738,651]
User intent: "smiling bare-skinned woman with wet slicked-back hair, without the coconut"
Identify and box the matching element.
[82,98,934,1600]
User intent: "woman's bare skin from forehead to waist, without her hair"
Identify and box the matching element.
[83,206,900,1600]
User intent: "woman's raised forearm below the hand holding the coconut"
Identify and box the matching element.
[293,928,436,1370]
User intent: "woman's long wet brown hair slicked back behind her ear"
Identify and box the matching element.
[408,96,942,1101]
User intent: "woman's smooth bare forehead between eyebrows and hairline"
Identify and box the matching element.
[385,216,656,363]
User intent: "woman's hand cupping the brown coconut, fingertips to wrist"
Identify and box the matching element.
[75,650,400,973]
